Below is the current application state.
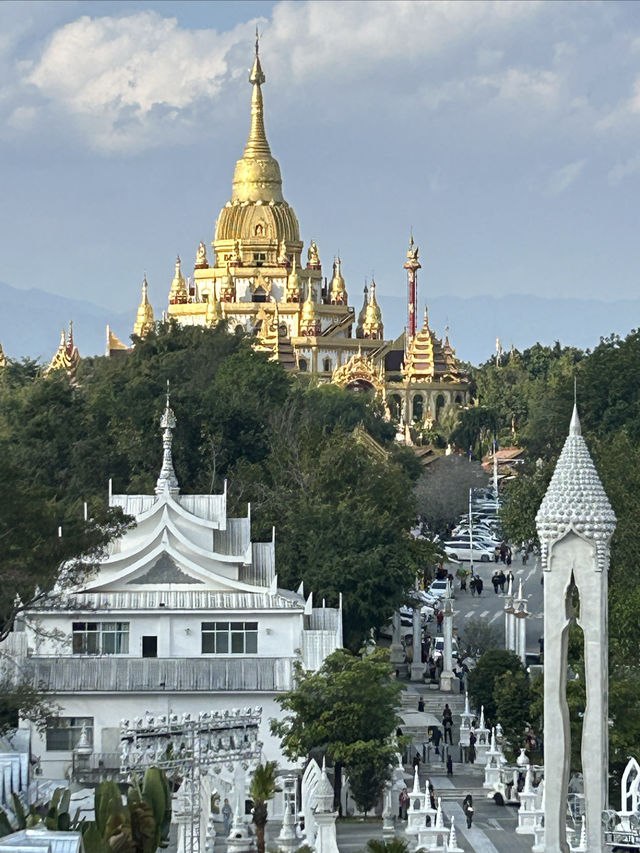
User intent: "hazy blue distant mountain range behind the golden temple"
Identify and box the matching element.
[0,282,640,364]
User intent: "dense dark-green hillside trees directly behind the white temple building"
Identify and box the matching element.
[0,322,435,649]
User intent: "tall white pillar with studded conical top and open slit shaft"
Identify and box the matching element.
[536,406,616,853]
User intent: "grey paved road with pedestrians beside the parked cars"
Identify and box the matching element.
[445,555,543,654]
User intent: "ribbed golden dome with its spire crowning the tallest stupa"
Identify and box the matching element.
[213,40,302,267]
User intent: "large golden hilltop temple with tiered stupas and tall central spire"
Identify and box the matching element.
[114,41,469,424]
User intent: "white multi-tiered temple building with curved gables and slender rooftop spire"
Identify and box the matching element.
[21,396,342,777]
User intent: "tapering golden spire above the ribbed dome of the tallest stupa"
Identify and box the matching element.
[232,30,284,203]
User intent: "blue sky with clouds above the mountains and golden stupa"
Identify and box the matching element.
[0,0,640,352]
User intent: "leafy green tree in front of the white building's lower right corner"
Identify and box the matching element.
[270,649,402,811]
